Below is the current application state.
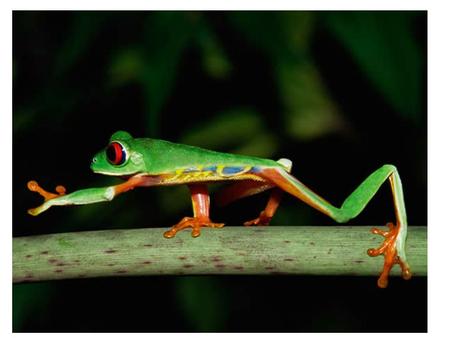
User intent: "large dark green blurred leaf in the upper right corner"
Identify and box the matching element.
[325,12,425,122]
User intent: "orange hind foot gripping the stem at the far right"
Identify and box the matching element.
[367,223,411,288]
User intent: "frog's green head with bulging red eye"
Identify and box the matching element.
[91,131,145,176]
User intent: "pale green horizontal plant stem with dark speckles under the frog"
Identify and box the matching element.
[13,226,427,282]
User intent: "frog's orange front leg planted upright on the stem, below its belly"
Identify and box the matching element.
[164,184,224,238]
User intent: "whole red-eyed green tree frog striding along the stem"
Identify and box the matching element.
[28,131,411,287]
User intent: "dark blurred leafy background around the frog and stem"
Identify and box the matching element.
[13,11,427,332]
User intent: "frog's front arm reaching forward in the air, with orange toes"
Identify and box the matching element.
[27,176,149,216]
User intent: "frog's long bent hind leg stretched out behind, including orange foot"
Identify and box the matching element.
[255,165,411,287]
